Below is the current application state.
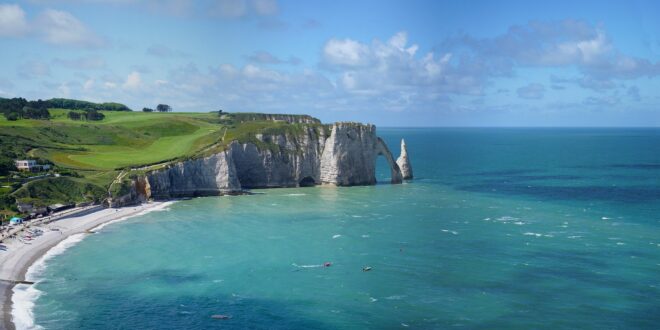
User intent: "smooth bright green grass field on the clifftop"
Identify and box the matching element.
[0,109,222,171]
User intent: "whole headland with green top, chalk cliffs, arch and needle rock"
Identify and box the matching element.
[0,98,412,222]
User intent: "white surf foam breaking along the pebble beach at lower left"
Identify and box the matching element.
[11,234,85,330]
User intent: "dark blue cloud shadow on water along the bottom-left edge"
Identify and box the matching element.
[43,289,332,329]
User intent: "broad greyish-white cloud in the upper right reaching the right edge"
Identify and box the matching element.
[442,20,660,80]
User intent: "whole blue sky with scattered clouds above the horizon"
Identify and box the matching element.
[0,0,660,127]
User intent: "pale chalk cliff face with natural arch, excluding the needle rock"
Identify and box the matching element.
[108,117,412,207]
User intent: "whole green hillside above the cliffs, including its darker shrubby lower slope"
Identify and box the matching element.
[0,104,321,218]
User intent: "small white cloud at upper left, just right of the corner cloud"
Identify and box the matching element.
[37,9,103,48]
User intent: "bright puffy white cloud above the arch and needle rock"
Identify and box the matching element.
[322,32,466,96]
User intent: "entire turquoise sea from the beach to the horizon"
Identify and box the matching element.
[28,129,660,329]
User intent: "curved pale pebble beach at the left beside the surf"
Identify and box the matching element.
[0,202,168,330]
